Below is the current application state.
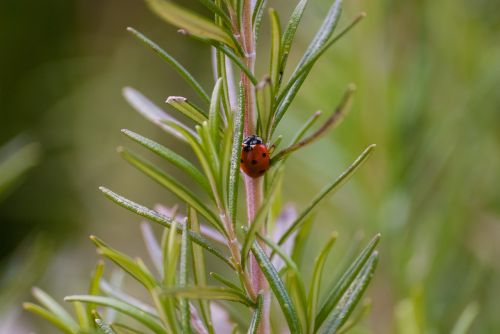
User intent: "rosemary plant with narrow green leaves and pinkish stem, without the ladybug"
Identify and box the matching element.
[24,0,379,333]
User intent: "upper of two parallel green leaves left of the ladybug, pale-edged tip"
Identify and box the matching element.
[122,129,211,194]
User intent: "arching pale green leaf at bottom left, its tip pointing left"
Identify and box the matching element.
[64,295,165,334]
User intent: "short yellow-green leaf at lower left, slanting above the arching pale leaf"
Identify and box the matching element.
[90,235,157,290]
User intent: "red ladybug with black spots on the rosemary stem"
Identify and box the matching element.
[240,135,270,178]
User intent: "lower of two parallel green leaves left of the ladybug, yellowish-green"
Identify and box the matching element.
[119,149,220,232]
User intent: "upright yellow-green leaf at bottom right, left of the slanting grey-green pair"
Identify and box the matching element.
[307,233,337,333]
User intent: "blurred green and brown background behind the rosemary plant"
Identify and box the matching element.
[0,0,500,333]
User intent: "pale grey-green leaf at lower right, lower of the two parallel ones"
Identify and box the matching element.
[318,252,378,334]
